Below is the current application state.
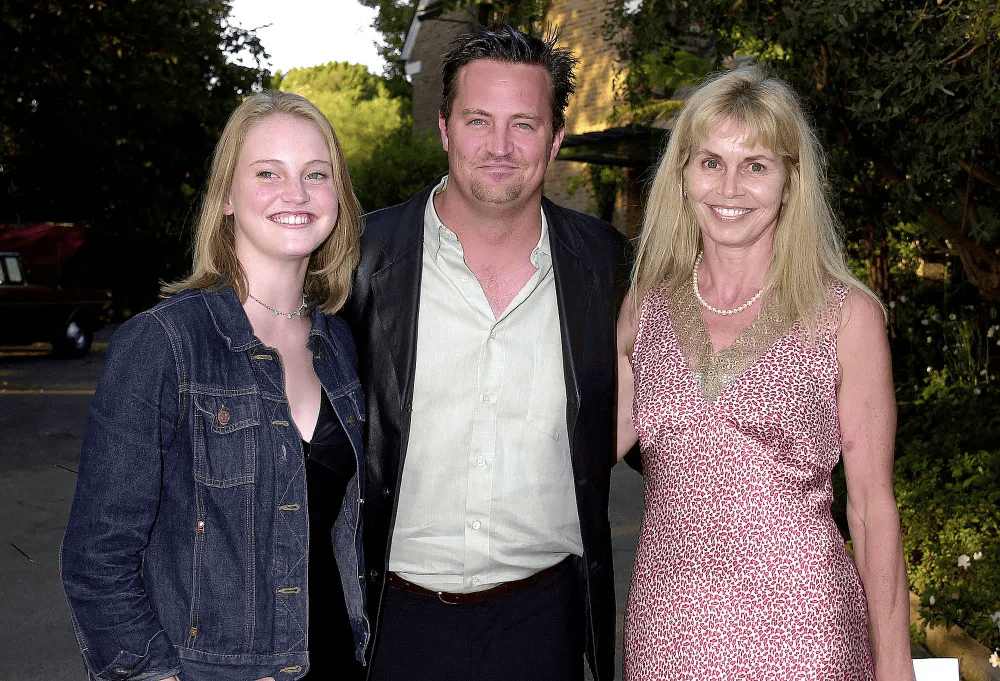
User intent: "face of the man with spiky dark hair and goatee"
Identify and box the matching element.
[438,59,564,210]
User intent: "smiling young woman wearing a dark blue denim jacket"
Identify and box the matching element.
[61,91,369,681]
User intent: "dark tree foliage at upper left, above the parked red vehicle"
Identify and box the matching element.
[0,0,263,309]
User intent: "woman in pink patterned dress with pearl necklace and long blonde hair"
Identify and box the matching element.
[619,67,912,681]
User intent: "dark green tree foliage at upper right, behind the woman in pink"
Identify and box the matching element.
[606,0,1000,301]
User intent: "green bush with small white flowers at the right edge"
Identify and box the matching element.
[895,380,1000,648]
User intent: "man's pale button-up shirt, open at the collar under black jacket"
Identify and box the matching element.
[389,178,583,592]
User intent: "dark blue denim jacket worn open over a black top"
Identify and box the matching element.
[60,288,370,681]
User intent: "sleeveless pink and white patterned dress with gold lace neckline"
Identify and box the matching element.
[624,282,875,681]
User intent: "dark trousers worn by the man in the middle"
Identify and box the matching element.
[369,561,585,681]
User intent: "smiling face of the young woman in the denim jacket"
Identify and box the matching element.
[224,113,339,267]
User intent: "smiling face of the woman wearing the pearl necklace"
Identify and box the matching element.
[684,118,788,255]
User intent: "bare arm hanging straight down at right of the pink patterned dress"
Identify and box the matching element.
[837,289,913,681]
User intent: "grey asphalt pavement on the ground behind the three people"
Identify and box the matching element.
[0,329,642,681]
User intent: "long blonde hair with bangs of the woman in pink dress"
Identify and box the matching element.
[631,66,874,321]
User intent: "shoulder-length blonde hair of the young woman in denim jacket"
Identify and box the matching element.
[161,90,361,314]
